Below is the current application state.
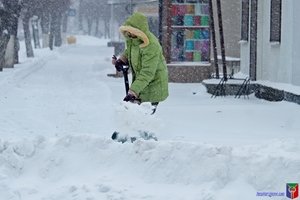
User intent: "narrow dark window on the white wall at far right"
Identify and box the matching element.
[270,0,282,42]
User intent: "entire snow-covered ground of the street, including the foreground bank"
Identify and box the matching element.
[0,36,300,200]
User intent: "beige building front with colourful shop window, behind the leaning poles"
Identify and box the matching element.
[161,0,241,82]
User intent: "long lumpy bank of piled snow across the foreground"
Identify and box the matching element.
[0,135,300,200]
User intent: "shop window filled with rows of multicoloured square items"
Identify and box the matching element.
[171,0,210,62]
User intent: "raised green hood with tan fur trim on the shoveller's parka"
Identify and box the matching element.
[120,12,150,48]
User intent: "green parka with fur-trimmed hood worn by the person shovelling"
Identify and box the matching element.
[120,12,169,103]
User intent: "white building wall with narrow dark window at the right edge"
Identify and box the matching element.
[241,0,300,86]
